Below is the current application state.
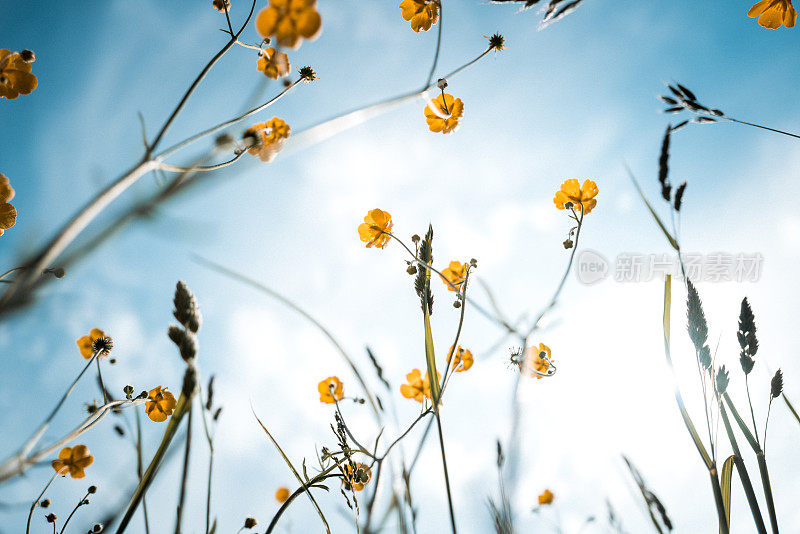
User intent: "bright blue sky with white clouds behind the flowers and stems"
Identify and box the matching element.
[0,0,800,532]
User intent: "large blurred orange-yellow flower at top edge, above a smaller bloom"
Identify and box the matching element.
[256,0,322,48]
